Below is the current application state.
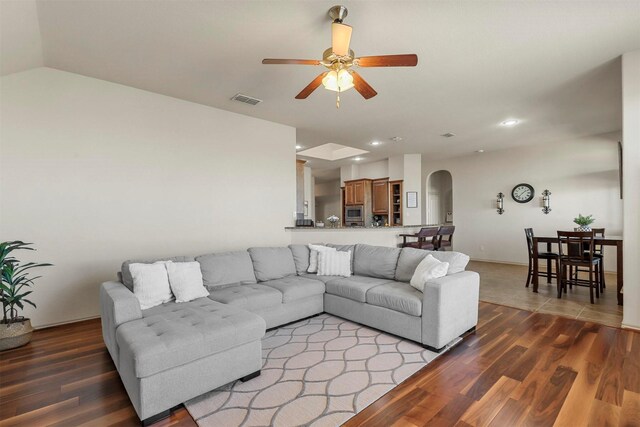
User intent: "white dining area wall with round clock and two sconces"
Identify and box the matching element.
[423,133,622,271]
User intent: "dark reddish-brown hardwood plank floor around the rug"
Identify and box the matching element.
[0,303,640,427]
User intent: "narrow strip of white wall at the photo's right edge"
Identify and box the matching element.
[622,50,640,329]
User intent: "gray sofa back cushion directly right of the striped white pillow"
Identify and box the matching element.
[353,244,400,280]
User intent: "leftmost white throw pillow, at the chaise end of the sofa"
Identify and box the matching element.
[129,261,173,310]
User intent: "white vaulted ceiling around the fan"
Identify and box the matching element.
[1,0,640,169]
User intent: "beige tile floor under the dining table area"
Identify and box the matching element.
[467,261,622,328]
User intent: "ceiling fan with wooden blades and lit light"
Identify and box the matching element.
[262,6,418,108]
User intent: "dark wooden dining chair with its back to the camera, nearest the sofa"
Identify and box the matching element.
[558,230,602,304]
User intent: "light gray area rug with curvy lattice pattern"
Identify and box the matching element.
[185,314,459,427]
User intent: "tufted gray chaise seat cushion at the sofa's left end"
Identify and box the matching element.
[116,298,266,378]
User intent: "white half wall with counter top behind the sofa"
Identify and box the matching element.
[285,224,449,247]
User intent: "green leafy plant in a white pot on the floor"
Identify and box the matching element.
[0,240,51,351]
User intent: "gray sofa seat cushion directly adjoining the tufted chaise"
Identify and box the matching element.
[209,284,282,311]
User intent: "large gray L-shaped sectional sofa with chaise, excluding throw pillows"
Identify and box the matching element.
[100,244,479,424]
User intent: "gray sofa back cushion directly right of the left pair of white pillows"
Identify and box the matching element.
[196,251,256,288]
